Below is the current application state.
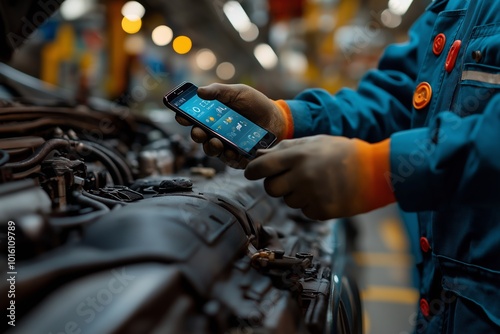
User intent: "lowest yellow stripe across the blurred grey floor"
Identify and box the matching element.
[361,285,419,305]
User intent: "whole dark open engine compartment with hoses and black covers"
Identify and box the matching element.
[0,64,362,334]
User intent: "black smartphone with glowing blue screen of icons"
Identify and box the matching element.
[163,82,276,159]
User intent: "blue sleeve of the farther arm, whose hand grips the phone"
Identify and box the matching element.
[286,8,435,142]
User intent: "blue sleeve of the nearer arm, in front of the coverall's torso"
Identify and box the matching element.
[388,94,500,211]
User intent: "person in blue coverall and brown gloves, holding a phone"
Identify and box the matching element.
[178,0,500,333]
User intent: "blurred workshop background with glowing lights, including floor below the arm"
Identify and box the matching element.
[5,0,430,334]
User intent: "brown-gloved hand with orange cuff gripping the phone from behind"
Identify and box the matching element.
[175,83,293,168]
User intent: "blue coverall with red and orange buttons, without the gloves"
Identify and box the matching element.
[286,0,500,333]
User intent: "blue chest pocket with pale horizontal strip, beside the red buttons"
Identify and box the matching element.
[452,23,500,117]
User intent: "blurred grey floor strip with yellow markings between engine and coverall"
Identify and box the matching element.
[353,205,419,334]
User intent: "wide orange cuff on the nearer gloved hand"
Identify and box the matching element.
[354,138,396,210]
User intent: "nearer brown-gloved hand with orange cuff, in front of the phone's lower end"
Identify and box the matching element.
[245,135,395,220]
